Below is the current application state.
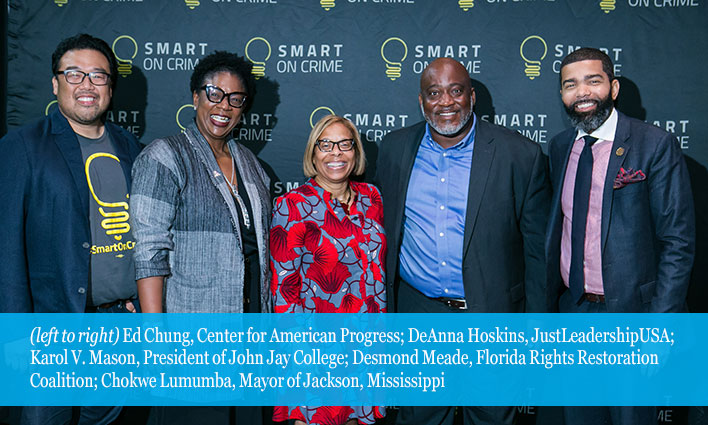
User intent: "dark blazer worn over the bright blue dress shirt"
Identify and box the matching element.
[376,119,551,313]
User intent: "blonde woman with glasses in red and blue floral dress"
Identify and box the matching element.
[270,115,386,425]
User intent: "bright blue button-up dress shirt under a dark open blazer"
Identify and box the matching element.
[399,115,477,298]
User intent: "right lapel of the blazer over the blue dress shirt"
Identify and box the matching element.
[462,119,494,257]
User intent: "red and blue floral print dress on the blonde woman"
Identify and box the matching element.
[270,179,386,424]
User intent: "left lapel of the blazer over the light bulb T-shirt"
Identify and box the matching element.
[52,111,89,220]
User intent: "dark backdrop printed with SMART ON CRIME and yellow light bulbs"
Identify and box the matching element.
[7,0,708,423]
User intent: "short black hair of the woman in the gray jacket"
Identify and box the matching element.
[189,50,256,105]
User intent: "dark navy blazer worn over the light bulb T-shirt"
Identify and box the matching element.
[0,110,141,313]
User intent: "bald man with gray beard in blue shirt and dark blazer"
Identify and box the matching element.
[376,58,550,425]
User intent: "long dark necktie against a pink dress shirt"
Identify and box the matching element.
[568,136,597,304]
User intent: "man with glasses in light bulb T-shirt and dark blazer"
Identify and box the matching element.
[0,34,140,425]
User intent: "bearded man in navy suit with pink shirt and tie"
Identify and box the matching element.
[547,48,695,425]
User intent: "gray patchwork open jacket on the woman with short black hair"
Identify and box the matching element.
[130,124,272,313]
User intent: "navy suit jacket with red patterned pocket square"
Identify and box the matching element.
[547,113,695,313]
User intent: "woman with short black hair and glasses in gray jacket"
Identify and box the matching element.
[130,51,271,313]
